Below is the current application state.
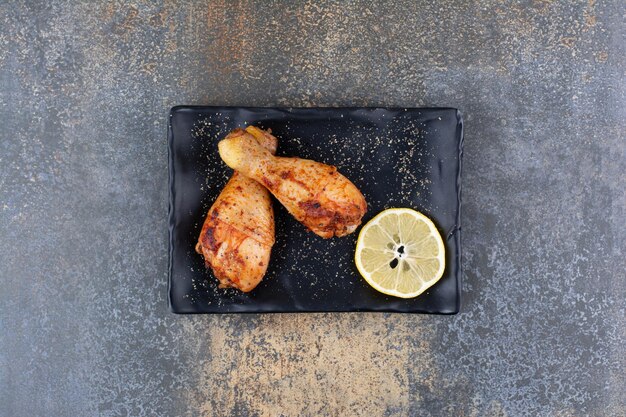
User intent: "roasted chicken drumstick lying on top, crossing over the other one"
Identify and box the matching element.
[218,135,367,238]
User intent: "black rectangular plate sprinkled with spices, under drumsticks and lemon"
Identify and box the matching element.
[169,106,463,314]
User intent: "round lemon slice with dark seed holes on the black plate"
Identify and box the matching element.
[354,208,445,298]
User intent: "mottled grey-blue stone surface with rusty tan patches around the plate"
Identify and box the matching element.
[0,0,626,417]
